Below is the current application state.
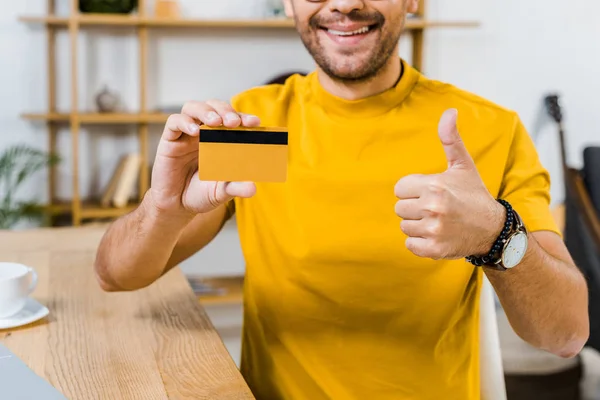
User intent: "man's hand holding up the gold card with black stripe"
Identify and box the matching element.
[150,100,260,219]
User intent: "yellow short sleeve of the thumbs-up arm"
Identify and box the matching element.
[500,117,562,237]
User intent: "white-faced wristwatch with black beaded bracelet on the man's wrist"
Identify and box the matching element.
[467,199,528,271]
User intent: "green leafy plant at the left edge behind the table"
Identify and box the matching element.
[0,144,60,229]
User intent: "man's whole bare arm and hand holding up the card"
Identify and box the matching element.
[95,100,260,291]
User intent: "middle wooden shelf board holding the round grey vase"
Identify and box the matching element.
[21,113,169,124]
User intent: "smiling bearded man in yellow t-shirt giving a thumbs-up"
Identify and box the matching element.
[96,0,588,400]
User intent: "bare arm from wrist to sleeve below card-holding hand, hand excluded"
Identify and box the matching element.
[95,191,226,291]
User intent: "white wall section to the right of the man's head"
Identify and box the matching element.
[426,0,600,202]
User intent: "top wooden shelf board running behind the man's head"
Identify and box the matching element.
[19,14,479,30]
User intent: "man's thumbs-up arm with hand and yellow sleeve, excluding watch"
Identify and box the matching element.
[396,112,589,357]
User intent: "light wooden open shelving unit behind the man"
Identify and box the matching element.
[20,0,479,225]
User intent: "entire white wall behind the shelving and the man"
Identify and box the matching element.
[0,0,600,269]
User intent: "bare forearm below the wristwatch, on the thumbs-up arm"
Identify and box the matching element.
[485,232,589,357]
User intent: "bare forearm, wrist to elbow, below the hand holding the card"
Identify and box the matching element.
[95,192,193,291]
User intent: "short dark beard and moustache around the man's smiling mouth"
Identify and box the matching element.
[296,10,404,82]
